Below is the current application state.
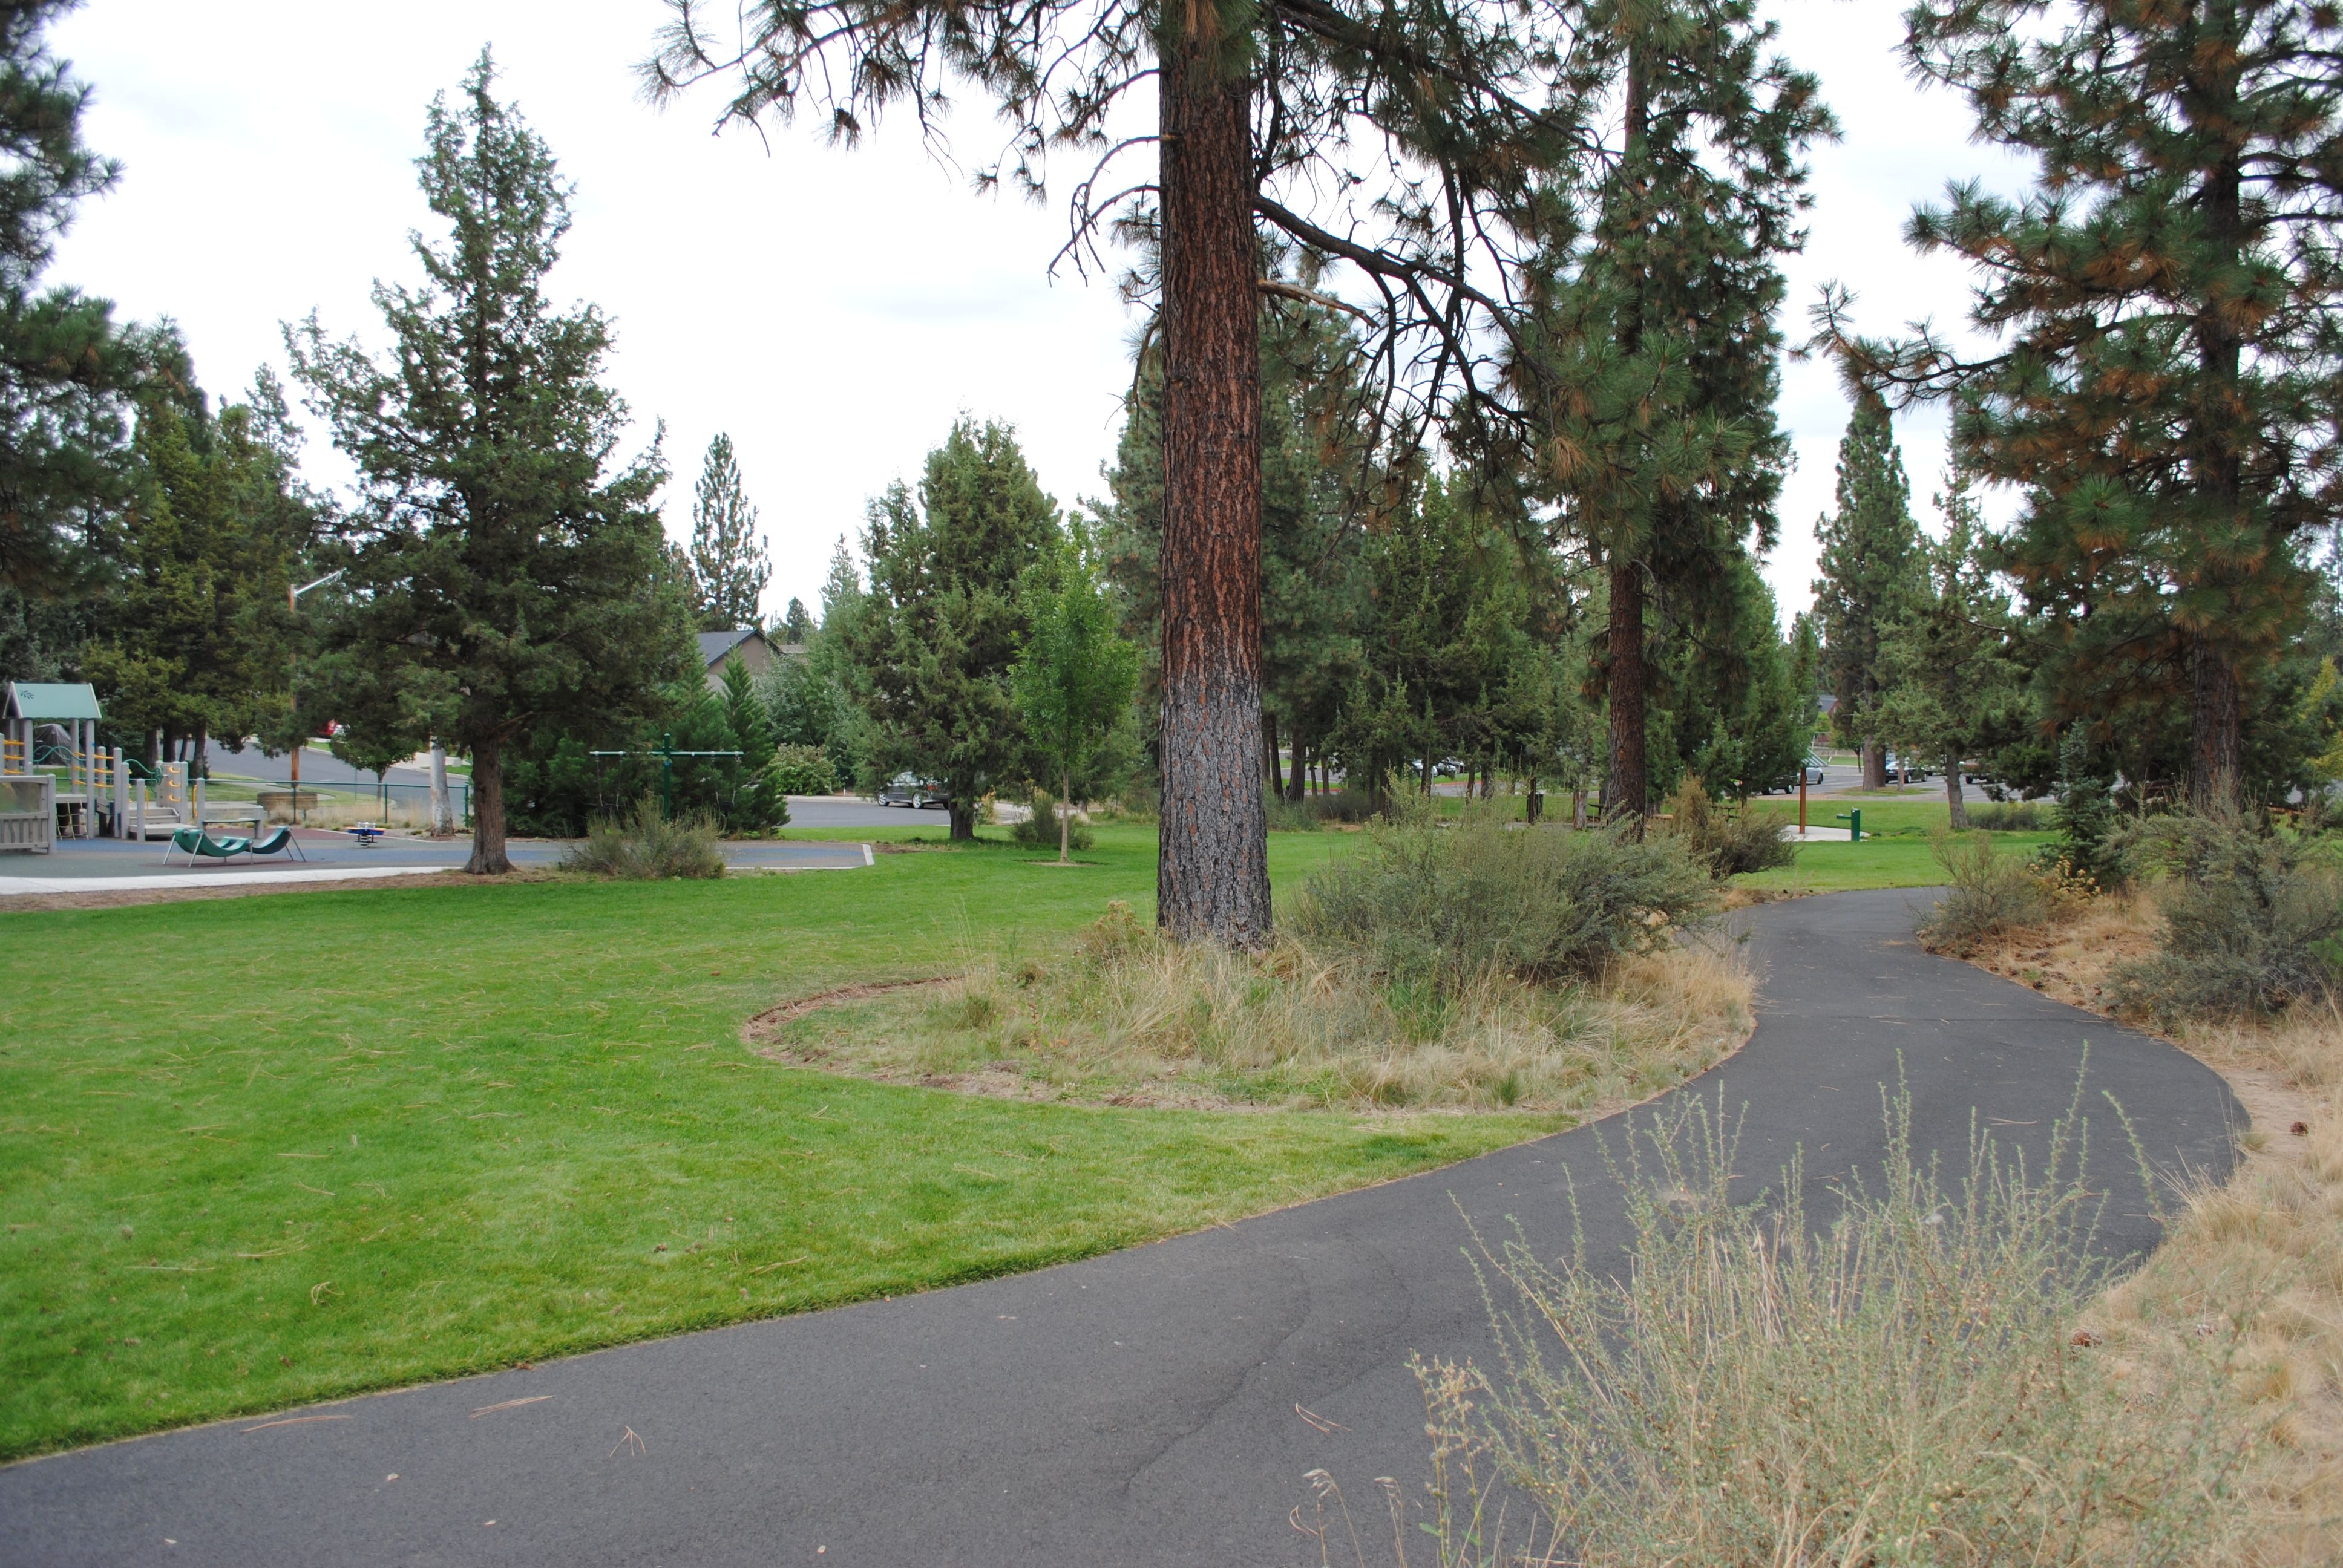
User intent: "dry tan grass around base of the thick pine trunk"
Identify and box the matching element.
[764,903,1755,1116]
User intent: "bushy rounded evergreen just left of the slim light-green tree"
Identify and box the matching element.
[843,420,1059,839]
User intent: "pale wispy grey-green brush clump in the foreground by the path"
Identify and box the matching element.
[1387,1097,2238,1568]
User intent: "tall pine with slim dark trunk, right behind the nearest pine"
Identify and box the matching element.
[1518,0,1832,818]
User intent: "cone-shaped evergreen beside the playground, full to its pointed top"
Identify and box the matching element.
[286,51,689,874]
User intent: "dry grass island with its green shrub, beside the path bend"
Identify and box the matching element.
[764,802,1752,1113]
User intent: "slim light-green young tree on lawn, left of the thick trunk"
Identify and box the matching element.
[1012,534,1139,865]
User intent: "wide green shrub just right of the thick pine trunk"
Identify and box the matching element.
[1291,797,1715,994]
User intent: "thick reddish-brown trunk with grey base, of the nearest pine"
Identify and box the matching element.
[1155,24,1270,947]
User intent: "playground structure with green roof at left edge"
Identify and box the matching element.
[0,682,260,853]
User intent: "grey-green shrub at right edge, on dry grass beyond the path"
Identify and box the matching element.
[2115,806,2343,1022]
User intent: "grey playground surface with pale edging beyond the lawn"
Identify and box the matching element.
[0,828,870,898]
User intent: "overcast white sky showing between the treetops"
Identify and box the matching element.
[51,0,2010,614]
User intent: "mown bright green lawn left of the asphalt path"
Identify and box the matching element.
[0,820,1558,1455]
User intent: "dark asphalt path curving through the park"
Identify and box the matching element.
[0,890,2244,1568]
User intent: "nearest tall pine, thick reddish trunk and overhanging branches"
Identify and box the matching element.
[651,0,1591,944]
